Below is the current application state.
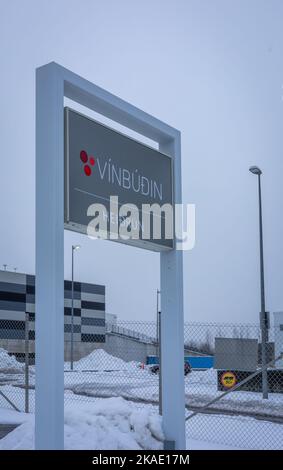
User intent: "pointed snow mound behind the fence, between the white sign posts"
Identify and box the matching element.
[65,349,136,371]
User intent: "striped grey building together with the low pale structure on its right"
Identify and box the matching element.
[0,271,211,366]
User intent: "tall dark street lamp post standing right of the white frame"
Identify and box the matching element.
[249,166,268,399]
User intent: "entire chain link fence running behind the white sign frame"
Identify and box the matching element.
[0,314,283,449]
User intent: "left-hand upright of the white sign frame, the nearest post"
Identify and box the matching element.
[35,64,64,449]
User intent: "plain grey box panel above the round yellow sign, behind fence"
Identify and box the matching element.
[214,338,258,371]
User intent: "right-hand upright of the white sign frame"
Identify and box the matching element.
[160,133,186,450]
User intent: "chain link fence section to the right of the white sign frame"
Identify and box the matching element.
[185,324,283,449]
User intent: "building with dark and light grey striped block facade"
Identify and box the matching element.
[0,271,105,360]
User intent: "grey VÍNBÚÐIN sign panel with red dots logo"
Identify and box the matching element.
[65,108,174,251]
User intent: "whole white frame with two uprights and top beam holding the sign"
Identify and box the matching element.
[35,62,185,449]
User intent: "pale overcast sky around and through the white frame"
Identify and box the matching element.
[0,0,283,322]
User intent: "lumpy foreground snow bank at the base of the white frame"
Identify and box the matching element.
[0,398,164,450]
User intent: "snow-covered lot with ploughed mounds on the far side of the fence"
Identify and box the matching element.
[0,349,283,418]
